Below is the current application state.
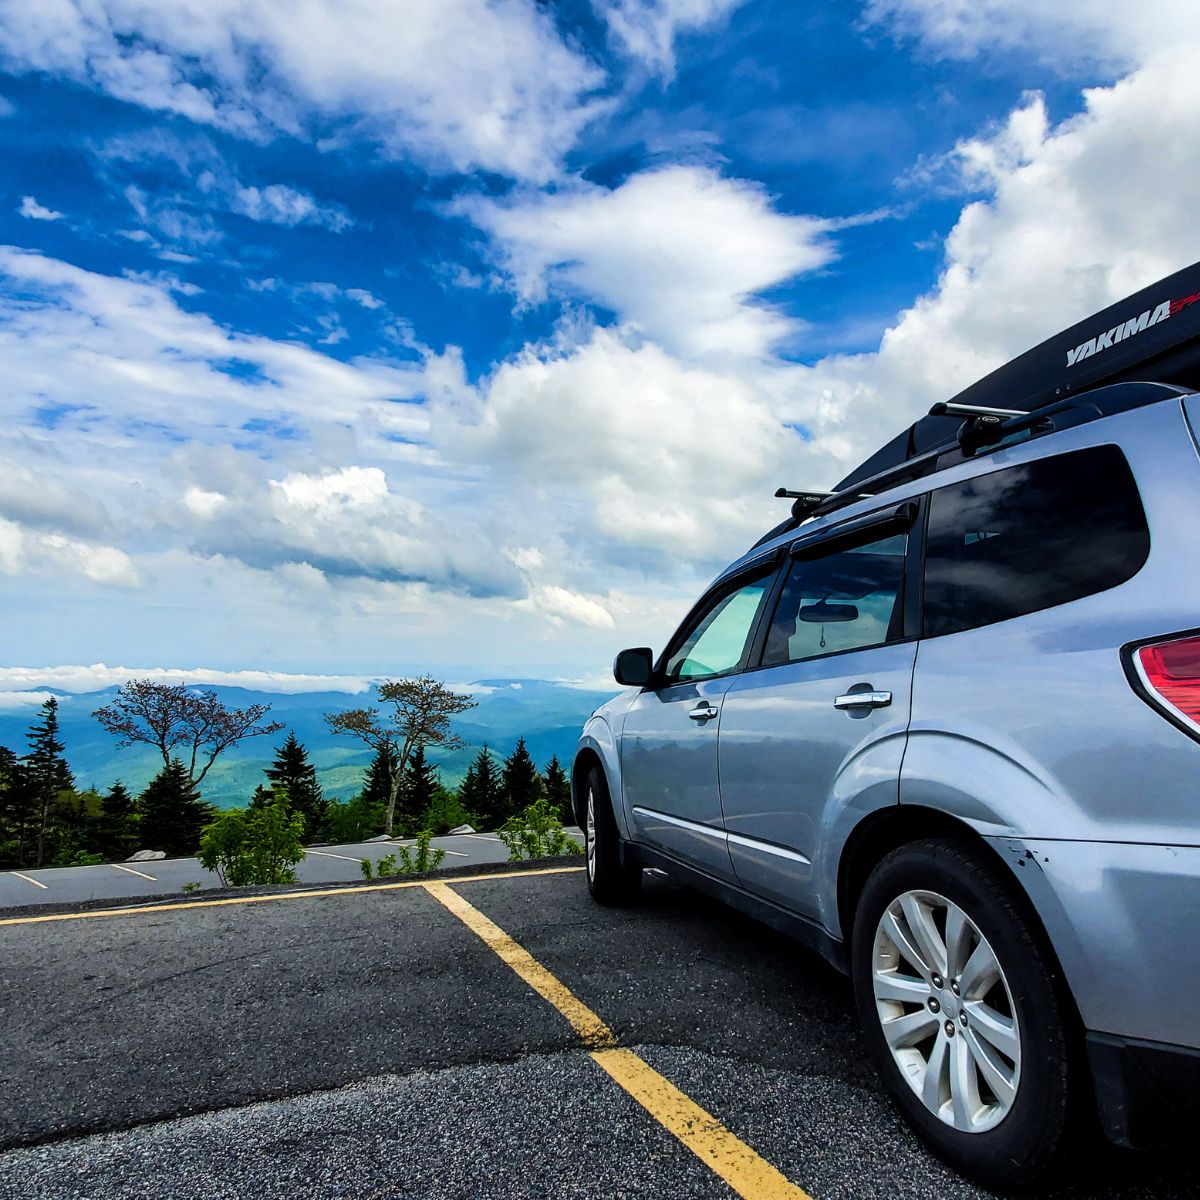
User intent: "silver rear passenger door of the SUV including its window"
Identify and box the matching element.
[719,506,917,917]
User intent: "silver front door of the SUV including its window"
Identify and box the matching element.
[620,559,775,880]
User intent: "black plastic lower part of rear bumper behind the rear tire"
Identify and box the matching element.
[1087,1033,1200,1148]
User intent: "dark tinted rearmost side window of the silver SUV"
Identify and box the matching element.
[924,445,1150,637]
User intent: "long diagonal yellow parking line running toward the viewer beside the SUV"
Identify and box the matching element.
[424,880,812,1200]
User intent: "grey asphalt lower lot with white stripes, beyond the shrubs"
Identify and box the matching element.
[0,828,547,910]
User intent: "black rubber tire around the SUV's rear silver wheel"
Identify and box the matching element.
[851,839,1080,1189]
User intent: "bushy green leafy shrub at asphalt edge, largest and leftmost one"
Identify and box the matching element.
[197,790,304,888]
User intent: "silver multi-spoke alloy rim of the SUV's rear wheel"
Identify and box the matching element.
[871,892,1021,1133]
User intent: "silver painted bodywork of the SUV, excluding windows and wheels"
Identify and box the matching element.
[584,395,1200,1046]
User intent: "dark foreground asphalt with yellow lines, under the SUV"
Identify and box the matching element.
[0,864,1200,1200]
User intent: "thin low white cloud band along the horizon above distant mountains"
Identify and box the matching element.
[0,662,372,704]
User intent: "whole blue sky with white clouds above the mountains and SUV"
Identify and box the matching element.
[0,0,1200,688]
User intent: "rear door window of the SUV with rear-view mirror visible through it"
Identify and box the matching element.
[762,533,908,666]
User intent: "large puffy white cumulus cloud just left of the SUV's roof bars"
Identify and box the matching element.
[446,329,800,559]
